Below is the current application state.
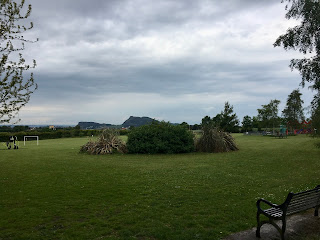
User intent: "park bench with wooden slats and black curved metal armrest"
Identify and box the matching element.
[256,185,320,240]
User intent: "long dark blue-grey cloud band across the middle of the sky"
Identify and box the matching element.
[36,57,292,101]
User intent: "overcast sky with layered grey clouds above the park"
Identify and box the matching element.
[13,0,312,125]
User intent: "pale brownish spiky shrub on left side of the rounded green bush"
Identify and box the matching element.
[80,129,127,155]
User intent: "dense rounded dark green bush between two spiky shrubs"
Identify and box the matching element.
[127,122,194,154]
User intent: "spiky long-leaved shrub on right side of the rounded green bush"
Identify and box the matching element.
[196,126,239,153]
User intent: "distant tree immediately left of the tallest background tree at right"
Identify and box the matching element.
[258,99,280,134]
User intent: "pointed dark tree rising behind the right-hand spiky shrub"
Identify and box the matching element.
[220,102,239,132]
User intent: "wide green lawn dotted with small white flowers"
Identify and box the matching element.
[0,134,320,240]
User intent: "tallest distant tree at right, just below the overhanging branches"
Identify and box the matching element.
[282,89,304,128]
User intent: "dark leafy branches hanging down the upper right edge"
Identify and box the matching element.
[274,0,320,128]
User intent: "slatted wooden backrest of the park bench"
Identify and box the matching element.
[287,185,320,215]
